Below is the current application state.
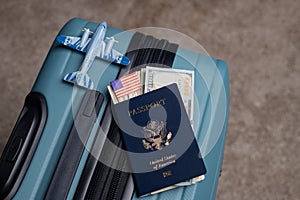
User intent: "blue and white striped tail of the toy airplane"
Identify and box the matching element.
[64,71,94,90]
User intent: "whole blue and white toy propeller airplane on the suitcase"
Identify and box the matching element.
[56,22,130,89]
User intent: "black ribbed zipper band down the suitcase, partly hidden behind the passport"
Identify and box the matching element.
[74,33,178,200]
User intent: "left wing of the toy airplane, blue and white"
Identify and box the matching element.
[56,35,91,52]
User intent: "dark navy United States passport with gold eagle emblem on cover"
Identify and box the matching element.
[112,83,206,196]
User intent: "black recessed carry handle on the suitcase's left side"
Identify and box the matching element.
[0,92,47,199]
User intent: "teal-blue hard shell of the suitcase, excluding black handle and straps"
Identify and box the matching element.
[2,18,229,200]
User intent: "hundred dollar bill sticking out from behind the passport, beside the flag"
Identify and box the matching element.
[144,66,194,124]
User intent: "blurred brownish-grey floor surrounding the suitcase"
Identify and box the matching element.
[0,0,300,200]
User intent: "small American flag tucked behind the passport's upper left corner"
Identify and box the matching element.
[110,72,142,98]
